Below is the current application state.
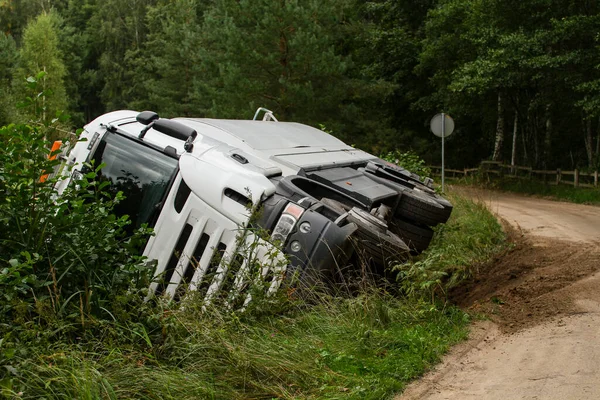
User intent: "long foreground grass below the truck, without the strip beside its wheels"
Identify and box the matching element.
[0,292,469,399]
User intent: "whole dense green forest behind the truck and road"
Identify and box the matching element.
[0,0,600,169]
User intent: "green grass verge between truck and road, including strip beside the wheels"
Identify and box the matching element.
[0,195,504,400]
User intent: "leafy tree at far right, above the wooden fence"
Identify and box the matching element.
[420,0,598,167]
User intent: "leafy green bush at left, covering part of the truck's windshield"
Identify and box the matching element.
[0,98,150,340]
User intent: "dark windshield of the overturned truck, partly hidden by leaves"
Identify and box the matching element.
[93,133,177,233]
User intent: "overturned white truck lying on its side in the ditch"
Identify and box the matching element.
[58,109,452,300]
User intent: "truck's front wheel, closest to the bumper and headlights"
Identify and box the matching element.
[347,207,410,266]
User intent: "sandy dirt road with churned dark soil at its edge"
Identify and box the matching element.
[397,192,600,400]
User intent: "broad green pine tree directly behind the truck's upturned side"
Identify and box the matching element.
[193,0,390,148]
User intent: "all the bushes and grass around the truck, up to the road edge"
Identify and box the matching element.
[0,97,504,399]
